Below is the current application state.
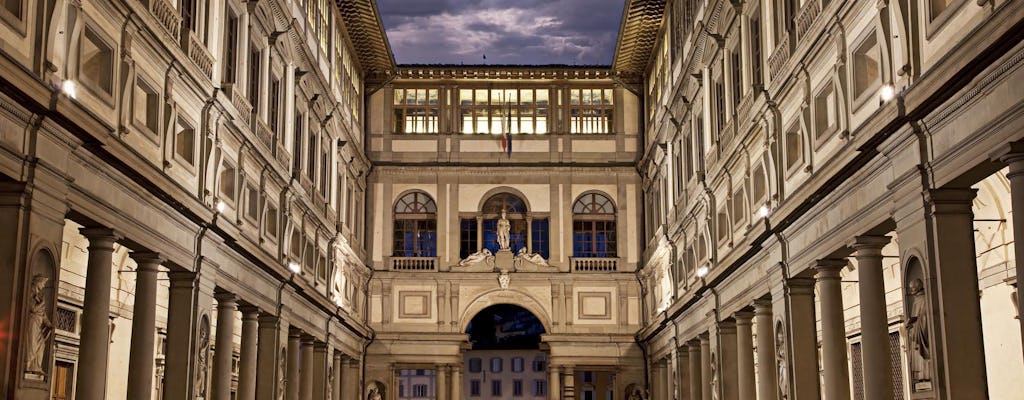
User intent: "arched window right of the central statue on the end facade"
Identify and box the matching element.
[572,193,617,258]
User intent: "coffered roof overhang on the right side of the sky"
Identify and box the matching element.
[611,0,667,83]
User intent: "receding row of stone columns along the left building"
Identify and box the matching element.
[67,227,360,400]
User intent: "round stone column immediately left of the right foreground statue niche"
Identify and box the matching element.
[851,236,892,400]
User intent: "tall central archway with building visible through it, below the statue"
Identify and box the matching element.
[463,304,549,400]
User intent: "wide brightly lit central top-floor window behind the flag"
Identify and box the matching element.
[459,89,550,134]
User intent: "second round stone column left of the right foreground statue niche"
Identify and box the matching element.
[814,259,851,400]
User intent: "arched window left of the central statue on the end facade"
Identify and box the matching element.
[392,191,437,257]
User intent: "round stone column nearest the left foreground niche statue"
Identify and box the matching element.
[75,227,120,400]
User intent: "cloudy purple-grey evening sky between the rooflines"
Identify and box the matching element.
[377,0,625,65]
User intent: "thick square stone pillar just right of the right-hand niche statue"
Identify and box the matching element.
[925,189,987,399]
